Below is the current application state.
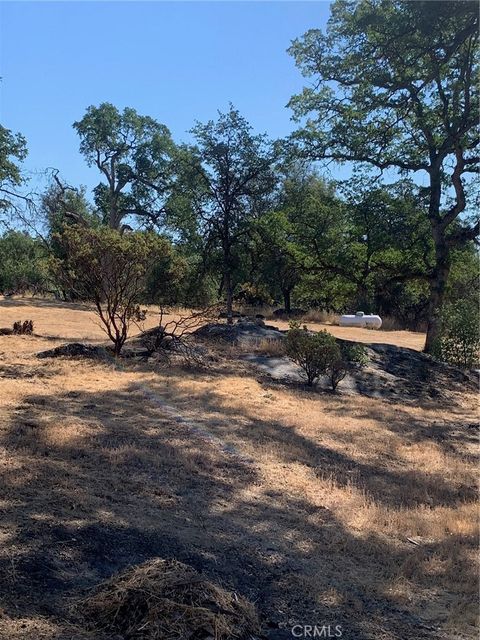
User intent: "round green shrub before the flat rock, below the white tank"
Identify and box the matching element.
[285,323,341,387]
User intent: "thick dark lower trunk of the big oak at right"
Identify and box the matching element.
[424,233,450,353]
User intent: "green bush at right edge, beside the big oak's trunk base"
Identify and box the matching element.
[434,300,480,369]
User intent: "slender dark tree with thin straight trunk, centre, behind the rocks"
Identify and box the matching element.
[185,107,274,323]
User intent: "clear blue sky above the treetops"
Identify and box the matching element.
[0,1,329,194]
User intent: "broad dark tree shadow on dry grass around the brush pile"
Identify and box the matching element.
[0,384,474,640]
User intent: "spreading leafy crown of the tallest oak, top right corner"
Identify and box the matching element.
[290,0,478,171]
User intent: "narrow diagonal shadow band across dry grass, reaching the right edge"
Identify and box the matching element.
[142,375,477,508]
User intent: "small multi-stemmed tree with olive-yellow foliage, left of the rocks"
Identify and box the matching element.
[55,225,171,356]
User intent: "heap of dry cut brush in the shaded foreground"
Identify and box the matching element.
[79,558,260,640]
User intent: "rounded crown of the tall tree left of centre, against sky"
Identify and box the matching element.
[73,102,175,229]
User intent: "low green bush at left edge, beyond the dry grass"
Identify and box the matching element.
[0,231,48,293]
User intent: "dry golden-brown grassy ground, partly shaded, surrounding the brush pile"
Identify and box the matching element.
[0,300,478,640]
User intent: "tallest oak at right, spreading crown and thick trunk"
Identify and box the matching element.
[290,0,479,351]
